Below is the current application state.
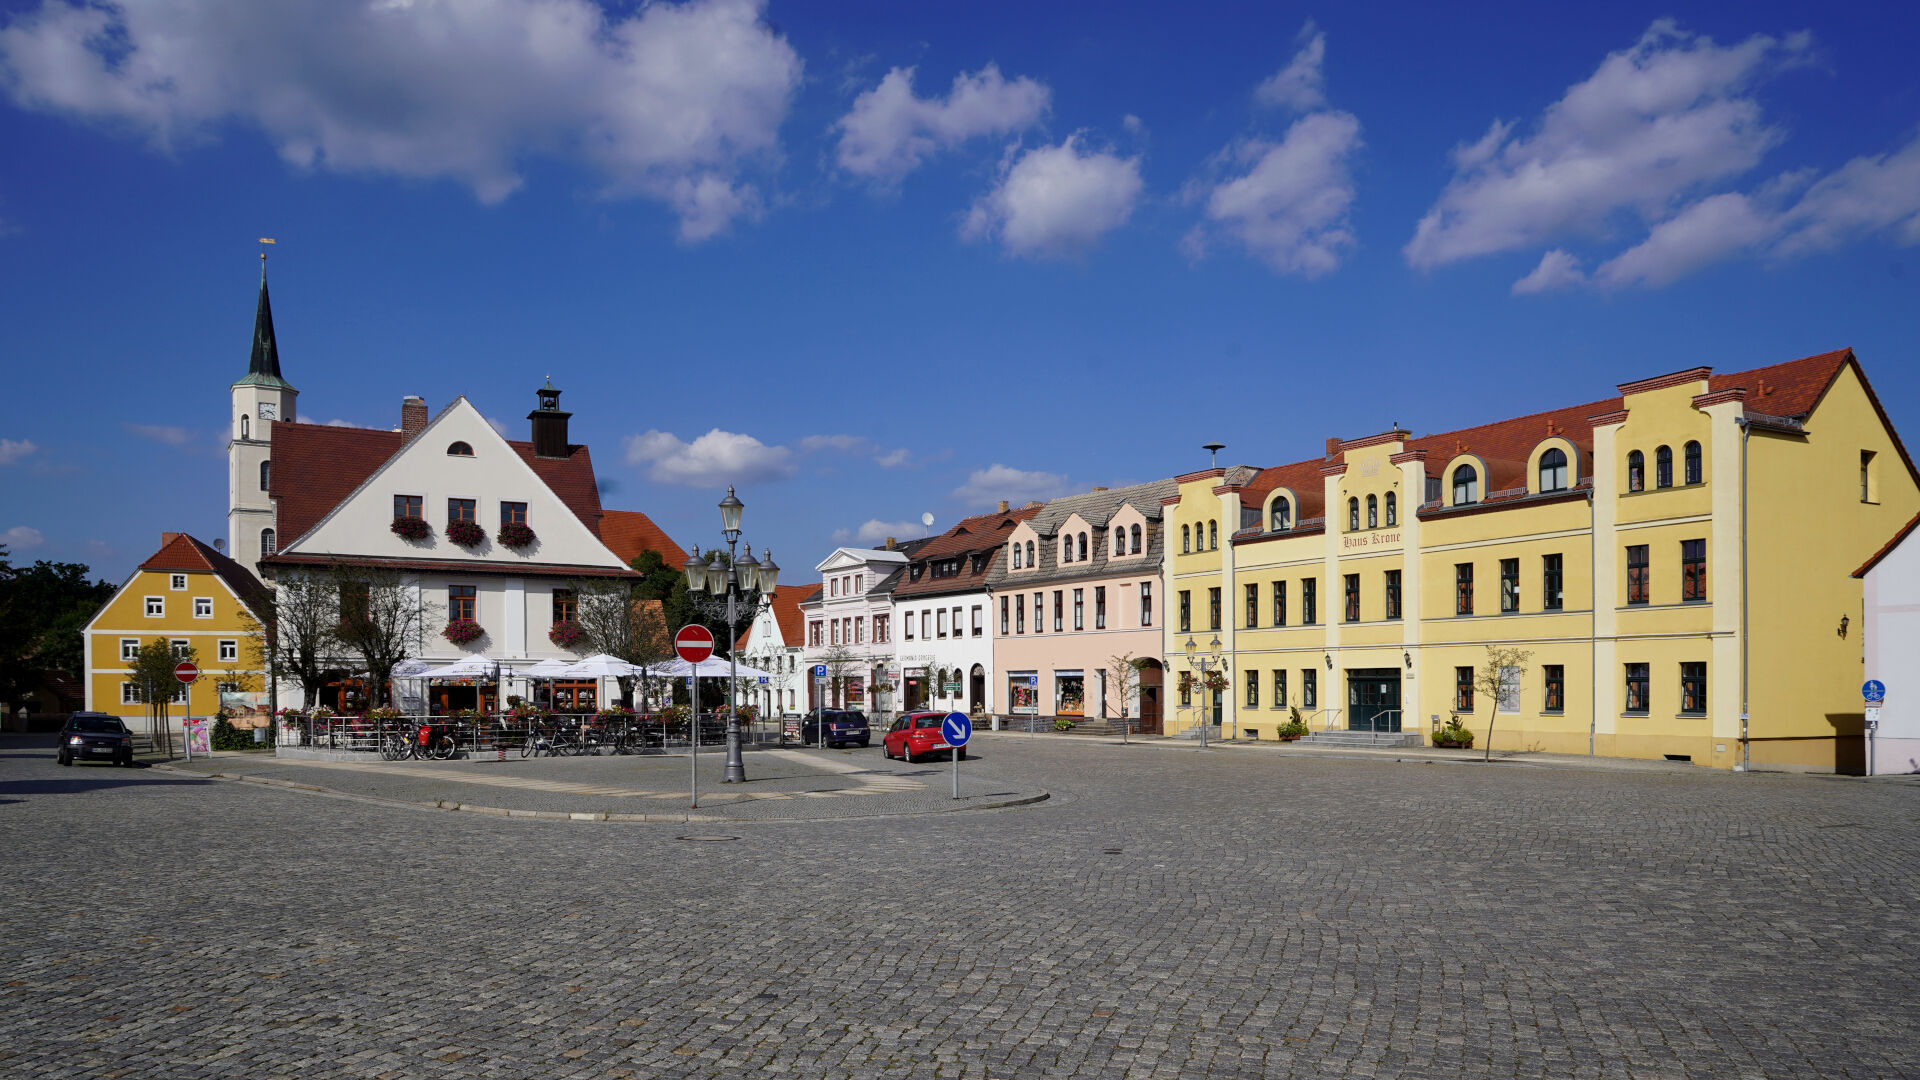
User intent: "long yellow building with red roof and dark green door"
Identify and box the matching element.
[1165,350,1920,773]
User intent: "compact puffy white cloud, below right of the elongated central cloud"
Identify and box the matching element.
[960,135,1144,258]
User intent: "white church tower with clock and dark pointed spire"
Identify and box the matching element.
[227,252,300,567]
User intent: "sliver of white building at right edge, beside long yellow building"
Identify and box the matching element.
[1853,517,1920,774]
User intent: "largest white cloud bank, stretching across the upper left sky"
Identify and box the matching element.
[0,0,801,240]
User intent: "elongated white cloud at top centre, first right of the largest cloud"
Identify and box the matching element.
[833,63,1052,186]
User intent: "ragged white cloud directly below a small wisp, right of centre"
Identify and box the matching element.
[1183,111,1361,277]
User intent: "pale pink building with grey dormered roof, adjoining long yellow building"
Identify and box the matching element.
[989,480,1179,734]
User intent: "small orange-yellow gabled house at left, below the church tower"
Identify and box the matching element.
[84,532,267,719]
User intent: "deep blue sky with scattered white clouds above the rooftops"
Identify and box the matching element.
[0,0,1920,580]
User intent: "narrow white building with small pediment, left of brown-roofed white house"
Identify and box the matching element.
[801,540,906,713]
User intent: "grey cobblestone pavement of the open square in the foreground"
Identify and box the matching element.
[0,736,1920,1080]
